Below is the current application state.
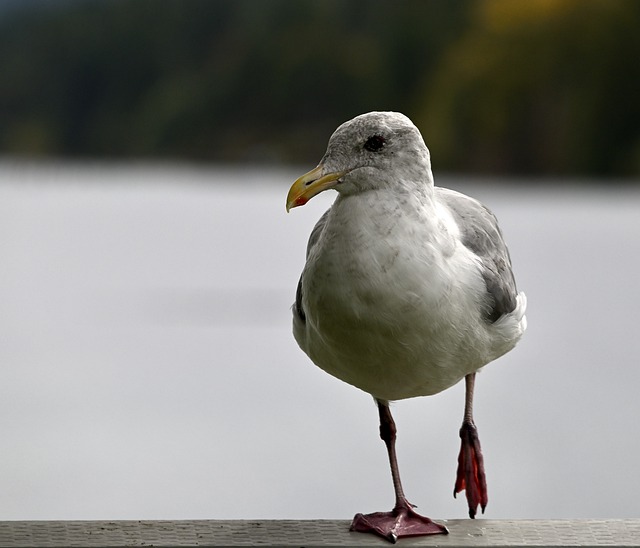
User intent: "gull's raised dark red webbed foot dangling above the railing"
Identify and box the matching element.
[453,421,489,519]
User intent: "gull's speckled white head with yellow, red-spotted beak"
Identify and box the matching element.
[287,112,433,211]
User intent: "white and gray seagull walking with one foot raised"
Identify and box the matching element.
[286,112,526,542]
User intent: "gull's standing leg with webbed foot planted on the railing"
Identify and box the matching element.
[351,400,449,543]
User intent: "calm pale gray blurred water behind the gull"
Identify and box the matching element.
[0,163,640,519]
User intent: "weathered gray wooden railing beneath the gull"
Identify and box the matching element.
[0,519,640,548]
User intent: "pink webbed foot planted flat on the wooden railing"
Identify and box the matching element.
[350,503,449,543]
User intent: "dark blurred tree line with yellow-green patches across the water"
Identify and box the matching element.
[0,0,640,177]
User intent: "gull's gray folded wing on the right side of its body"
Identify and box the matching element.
[436,187,518,323]
